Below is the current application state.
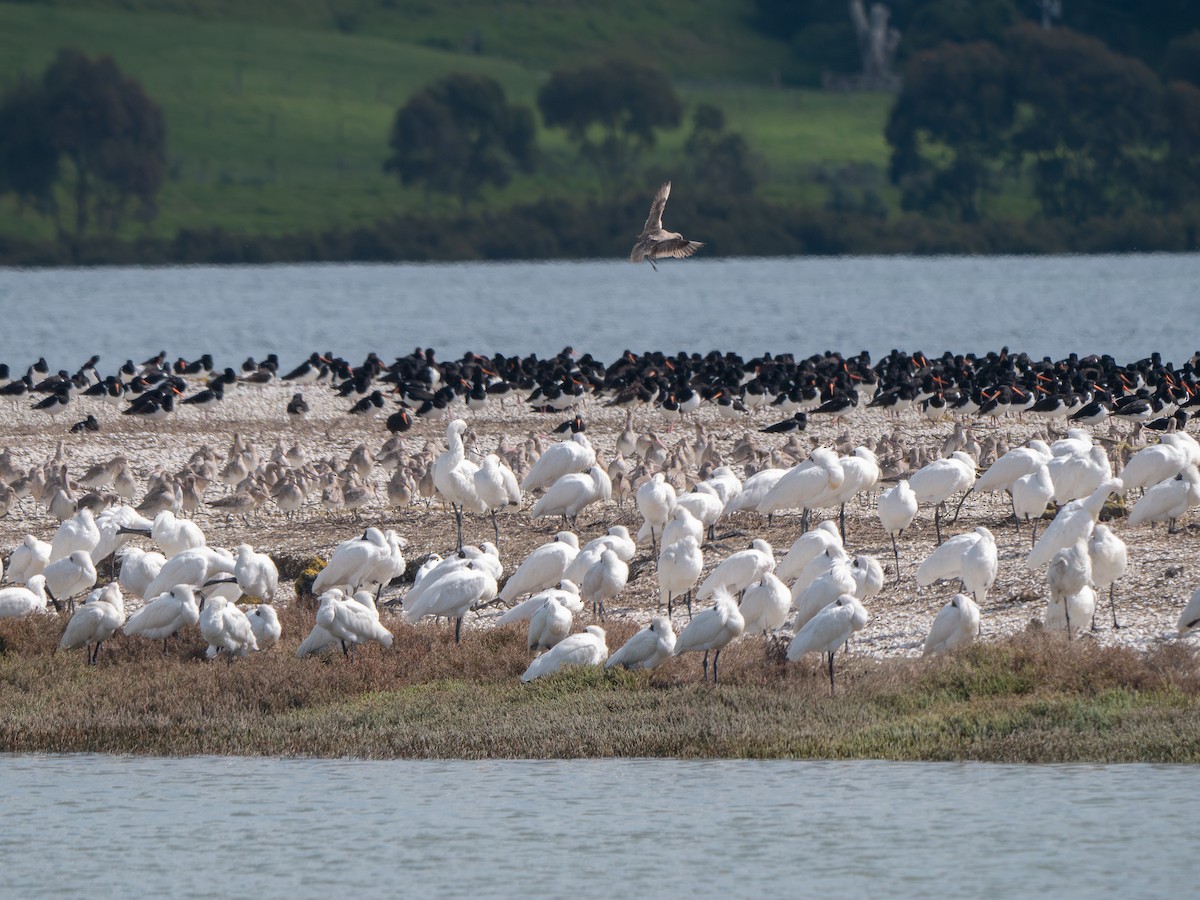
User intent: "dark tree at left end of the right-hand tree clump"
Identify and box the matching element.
[886,42,1016,222]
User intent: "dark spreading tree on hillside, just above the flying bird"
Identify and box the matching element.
[538,60,683,180]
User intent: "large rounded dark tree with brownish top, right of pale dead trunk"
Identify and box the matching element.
[1007,25,1163,222]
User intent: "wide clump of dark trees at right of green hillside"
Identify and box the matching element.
[887,23,1198,223]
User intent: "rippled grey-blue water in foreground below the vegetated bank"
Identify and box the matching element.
[0,755,1180,898]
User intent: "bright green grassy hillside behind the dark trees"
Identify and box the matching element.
[0,0,889,235]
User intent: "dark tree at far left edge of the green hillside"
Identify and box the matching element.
[0,49,167,247]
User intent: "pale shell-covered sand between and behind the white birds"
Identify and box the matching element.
[0,383,1200,656]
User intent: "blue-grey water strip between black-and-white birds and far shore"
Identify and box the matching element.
[0,254,1200,371]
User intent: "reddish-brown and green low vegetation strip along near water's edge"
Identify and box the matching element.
[0,610,1200,763]
